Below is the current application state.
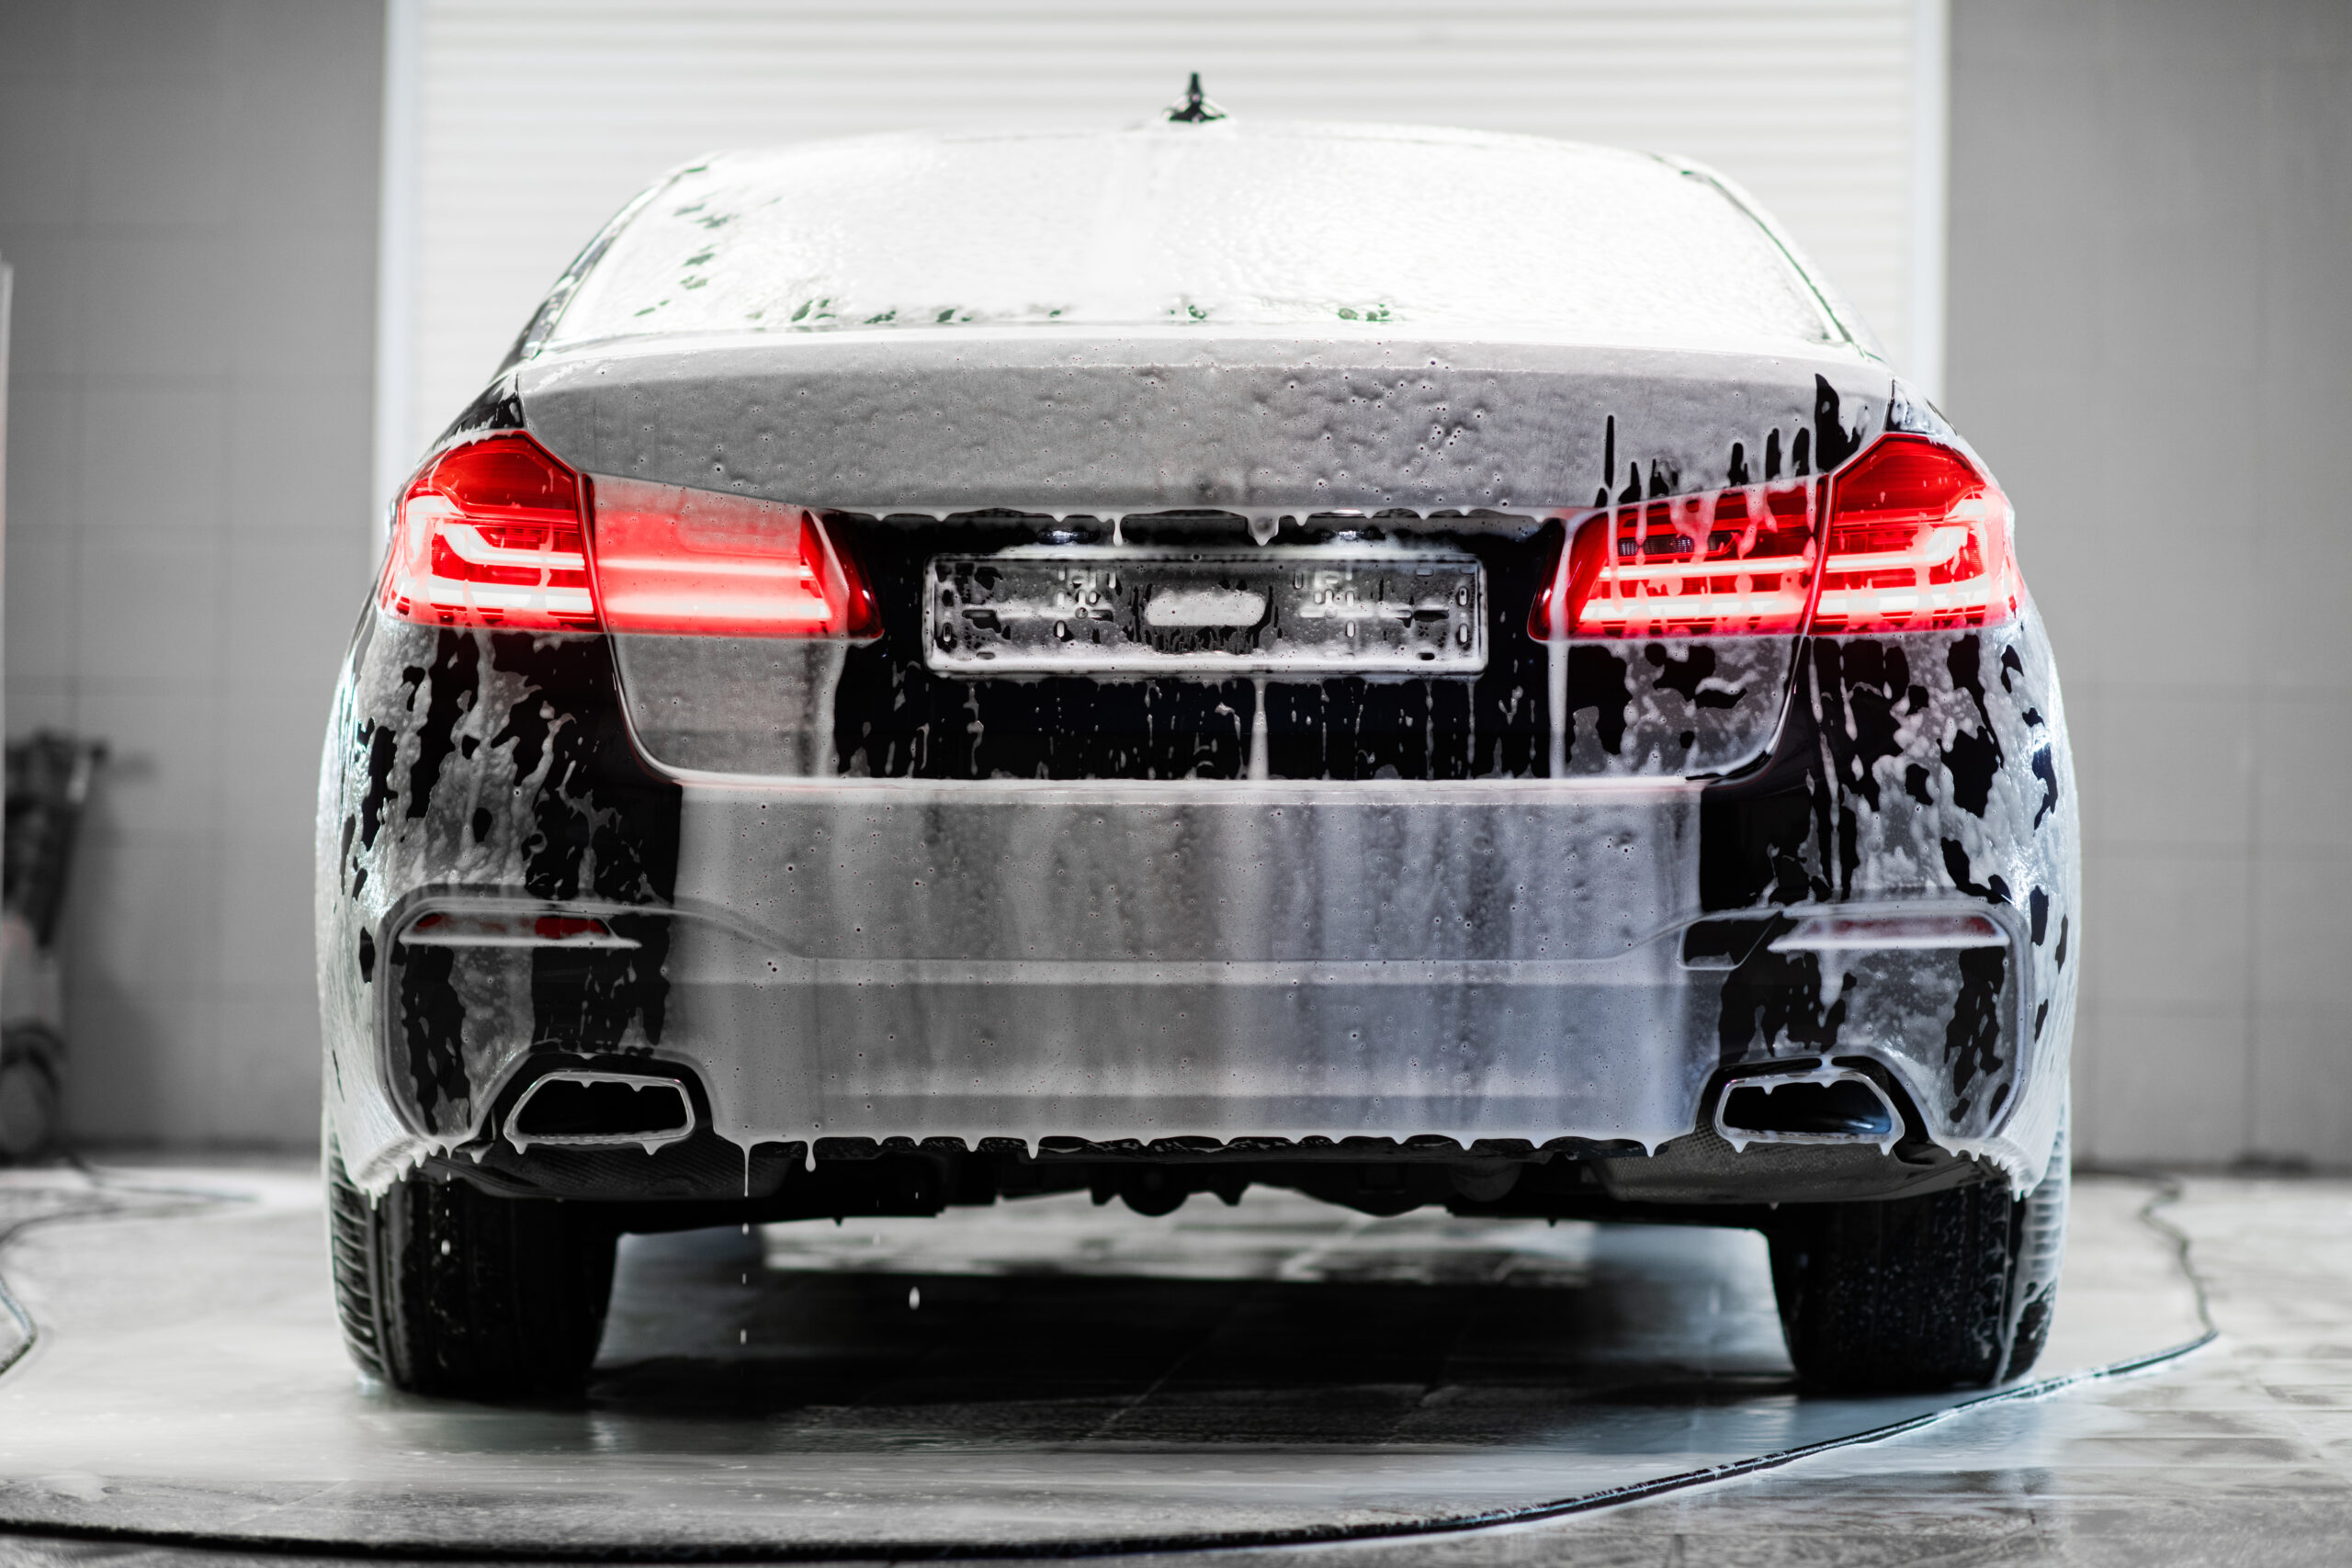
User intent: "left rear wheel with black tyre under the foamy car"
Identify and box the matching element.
[327,1149,618,1401]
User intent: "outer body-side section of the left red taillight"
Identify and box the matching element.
[381,430,595,630]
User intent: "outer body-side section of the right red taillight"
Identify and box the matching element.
[1814,434,2025,635]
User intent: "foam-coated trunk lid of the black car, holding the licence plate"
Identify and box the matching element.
[520,332,1889,781]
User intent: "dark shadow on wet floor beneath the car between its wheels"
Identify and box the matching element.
[588,1227,1790,1448]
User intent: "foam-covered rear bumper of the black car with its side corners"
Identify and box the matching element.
[318,616,2079,1201]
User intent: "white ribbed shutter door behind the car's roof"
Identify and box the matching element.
[404,0,1940,484]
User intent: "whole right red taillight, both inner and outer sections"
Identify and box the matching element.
[1526,434,2023,639]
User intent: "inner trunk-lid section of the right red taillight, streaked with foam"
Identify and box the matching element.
[1529,482,1814,639]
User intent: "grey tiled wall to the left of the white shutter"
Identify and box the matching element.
[0,0,383,1143]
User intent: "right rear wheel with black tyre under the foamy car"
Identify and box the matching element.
[1771,1117,2067,1394]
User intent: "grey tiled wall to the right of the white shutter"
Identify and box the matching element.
[1950,0,2352,1164]
